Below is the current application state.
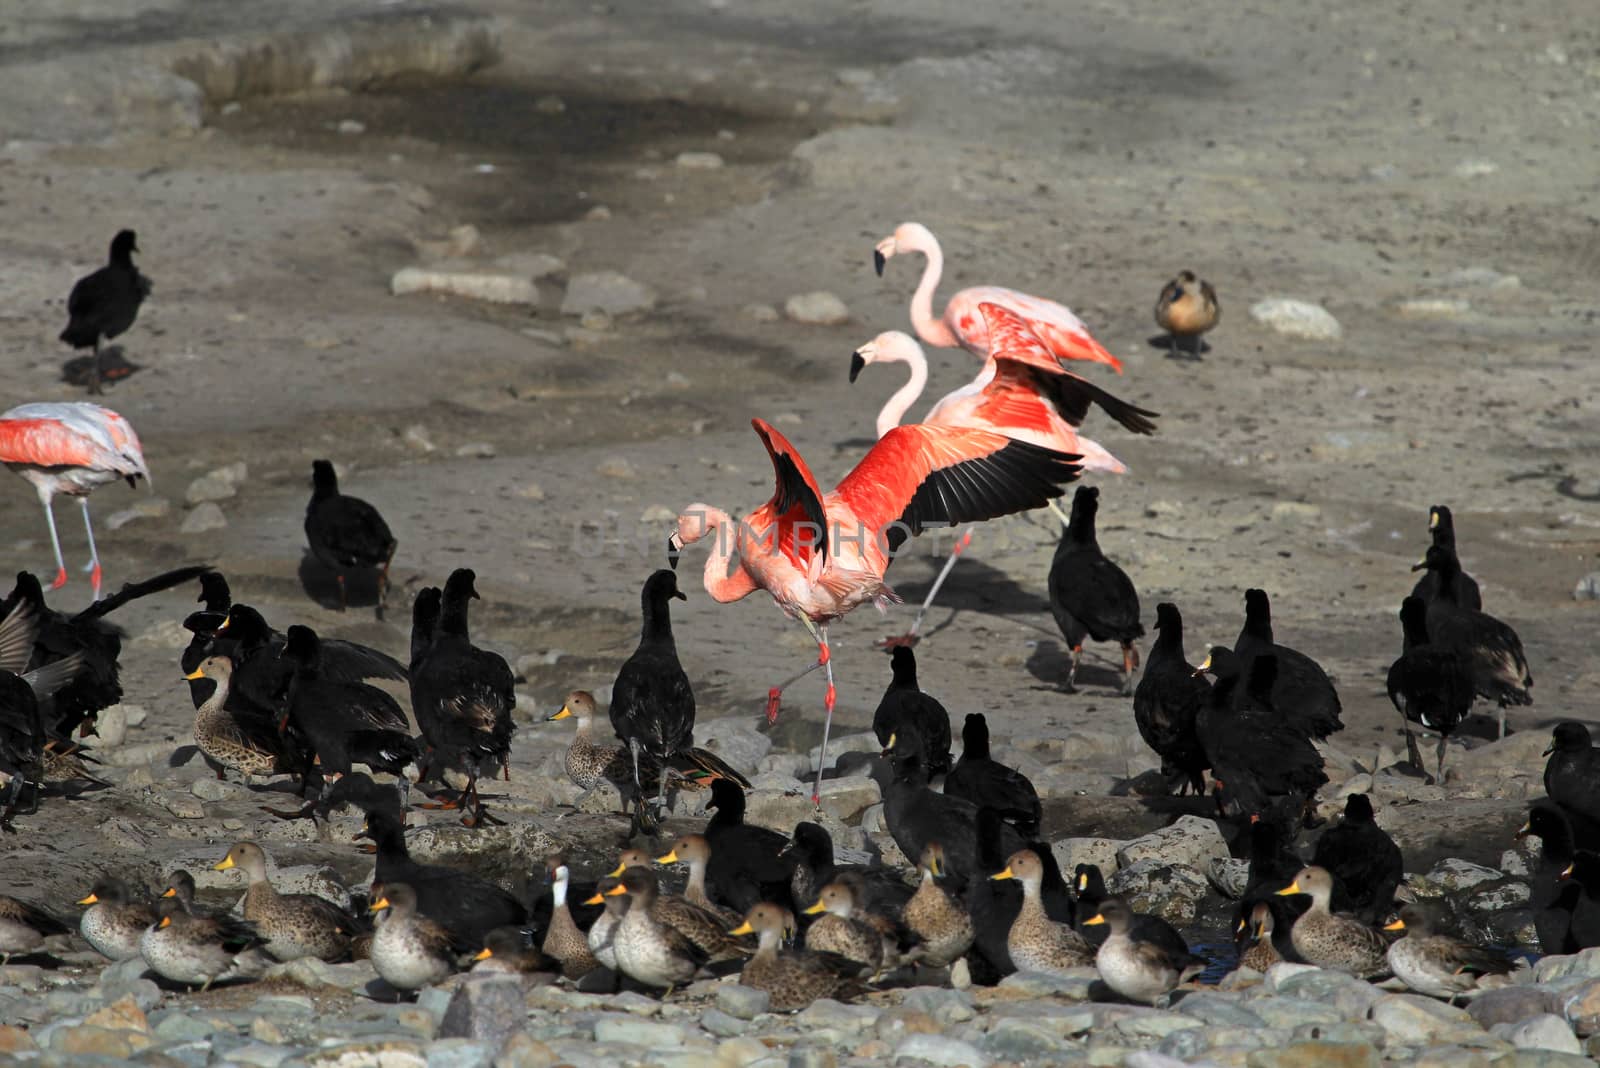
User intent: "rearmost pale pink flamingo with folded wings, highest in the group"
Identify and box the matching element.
[872,222,1122,374]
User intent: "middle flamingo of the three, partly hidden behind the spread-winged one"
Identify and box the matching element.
[850,302,1157,648]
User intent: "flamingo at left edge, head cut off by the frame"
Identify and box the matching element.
[0,401,150,601]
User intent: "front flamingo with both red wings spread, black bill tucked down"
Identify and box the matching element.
[667,419,1080,804]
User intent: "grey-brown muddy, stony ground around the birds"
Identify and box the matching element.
[0,0,1600,1063]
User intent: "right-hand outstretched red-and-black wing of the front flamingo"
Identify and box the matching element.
[835,424,1082,552]
